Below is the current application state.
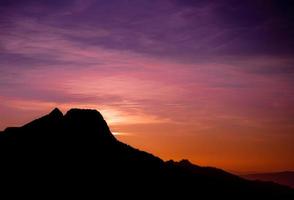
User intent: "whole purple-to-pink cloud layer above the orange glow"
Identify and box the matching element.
[0,1,293,134]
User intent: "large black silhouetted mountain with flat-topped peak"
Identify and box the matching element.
[0,109,294,200]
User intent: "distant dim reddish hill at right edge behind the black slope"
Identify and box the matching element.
[242,171,294,188]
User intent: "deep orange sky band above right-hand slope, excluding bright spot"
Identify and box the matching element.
[114,124,294,173]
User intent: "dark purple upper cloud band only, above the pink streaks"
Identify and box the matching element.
[1,0,294,62]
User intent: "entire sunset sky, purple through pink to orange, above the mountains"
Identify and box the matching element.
[0,0,294,172]
